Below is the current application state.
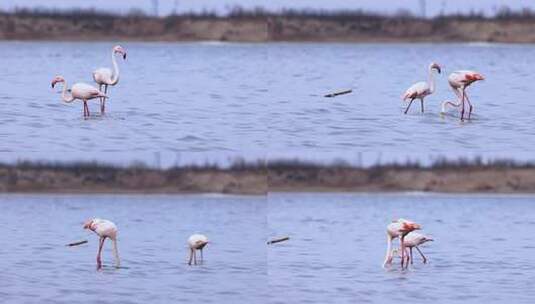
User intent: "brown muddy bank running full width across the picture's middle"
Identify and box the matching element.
[0,162,535,195]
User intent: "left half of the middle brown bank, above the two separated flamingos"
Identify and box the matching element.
[0,163,267,194]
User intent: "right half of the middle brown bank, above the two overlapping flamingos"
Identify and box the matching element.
[269,164,535,193]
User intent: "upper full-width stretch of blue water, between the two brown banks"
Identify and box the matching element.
[0,42,535,162]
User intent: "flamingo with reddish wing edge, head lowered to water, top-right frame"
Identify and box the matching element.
[442,71,485,121]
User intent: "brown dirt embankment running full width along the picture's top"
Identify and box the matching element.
[0,13,535,43]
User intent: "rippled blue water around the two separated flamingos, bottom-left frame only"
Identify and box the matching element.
[0,195,267,304]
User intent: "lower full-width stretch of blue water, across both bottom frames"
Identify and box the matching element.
[0,193,535,303]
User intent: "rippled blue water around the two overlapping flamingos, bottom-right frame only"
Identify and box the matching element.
[268,194,535,303]
